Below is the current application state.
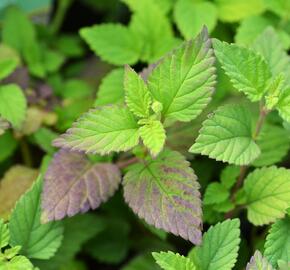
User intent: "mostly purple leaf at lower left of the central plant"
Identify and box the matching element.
[42,150,121,221]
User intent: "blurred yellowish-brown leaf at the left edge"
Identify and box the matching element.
[0,165,38,219]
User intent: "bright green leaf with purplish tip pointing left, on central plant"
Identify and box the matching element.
[54,106,139,155]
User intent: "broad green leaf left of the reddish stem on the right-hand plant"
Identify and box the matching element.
[189,105,260,165]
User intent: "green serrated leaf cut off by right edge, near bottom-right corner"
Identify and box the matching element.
[264,216,290,266]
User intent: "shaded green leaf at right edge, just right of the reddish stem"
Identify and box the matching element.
[253,125,290,167]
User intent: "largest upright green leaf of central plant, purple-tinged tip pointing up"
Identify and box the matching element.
[148,28,216,122]
